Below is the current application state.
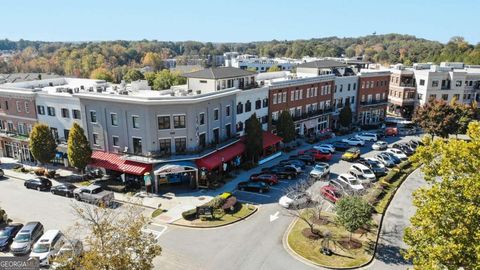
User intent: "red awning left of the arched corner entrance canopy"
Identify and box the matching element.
[90,151,152,175]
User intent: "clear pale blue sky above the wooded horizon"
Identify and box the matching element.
[0,0,480,44]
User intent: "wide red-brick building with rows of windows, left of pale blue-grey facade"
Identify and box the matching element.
[268,74,335,136]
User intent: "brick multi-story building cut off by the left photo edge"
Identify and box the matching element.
[0,83,39,161]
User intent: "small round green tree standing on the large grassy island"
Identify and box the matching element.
[335,196,372,241]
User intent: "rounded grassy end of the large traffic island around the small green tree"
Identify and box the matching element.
[286,214,379,269]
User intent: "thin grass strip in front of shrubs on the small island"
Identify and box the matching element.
[175,204,257,228]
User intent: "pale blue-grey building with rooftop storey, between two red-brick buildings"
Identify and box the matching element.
[297,60,358,128]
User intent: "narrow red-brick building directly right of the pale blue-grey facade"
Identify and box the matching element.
[356,69,390,126]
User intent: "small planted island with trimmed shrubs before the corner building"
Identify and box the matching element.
[173,192,258,228]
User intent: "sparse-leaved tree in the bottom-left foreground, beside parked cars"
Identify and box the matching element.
[60,204,162,270]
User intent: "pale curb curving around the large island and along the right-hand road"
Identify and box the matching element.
[282,167,420,270]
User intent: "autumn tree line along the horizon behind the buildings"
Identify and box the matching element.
[0,34,480,79]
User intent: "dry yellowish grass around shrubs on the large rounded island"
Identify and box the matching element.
[287,214,378,268]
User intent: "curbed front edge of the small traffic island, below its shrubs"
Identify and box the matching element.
[172,202,258,228]
